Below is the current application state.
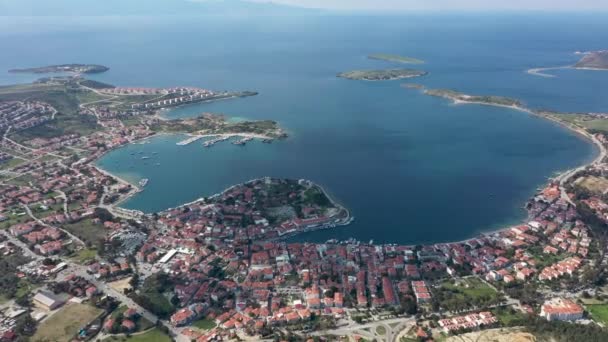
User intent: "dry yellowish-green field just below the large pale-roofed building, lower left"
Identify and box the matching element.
[31,303,103,342]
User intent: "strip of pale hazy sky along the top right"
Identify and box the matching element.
[249,0,608,11]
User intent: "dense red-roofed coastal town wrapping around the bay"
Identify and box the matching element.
[0,78,608,342]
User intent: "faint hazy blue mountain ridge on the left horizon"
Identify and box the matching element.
[0,0,316,16]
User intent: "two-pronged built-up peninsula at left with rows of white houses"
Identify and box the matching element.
[0,76,287,146]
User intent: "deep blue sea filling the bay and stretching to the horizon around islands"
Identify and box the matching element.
[0,13,608,244]
